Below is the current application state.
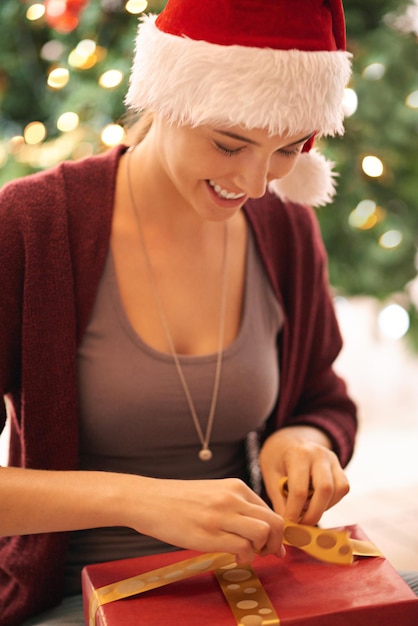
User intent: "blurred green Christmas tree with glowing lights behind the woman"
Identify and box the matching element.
[0,0,418,349]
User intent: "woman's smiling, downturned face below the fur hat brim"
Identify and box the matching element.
[149,118,312,221]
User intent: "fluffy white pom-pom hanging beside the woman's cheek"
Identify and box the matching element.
[269,149,338,206]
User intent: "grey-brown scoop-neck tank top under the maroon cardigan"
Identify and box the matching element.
[66,227,283,595]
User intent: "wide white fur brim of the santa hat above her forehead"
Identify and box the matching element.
[126,16,351,136]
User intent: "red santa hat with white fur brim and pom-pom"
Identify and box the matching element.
[126,0,351,206]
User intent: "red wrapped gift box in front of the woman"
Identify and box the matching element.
[82,526,418,626]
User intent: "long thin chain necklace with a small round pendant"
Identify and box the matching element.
[126,147,229,461]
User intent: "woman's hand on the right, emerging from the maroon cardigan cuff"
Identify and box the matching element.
[260,426,349,526]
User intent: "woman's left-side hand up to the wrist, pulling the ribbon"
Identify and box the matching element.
[124,478,284,563]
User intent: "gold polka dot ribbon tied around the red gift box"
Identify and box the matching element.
[89,520,382,626]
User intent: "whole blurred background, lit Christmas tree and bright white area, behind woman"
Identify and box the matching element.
[0,0,418,570]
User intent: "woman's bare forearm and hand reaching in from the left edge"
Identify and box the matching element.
[0,467,283,562]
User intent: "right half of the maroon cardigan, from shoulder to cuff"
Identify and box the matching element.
[246,194,357,465]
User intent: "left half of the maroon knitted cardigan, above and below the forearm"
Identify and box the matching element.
[0,150,120,626]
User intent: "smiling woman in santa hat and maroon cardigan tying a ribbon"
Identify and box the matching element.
[0,0,356,626]
